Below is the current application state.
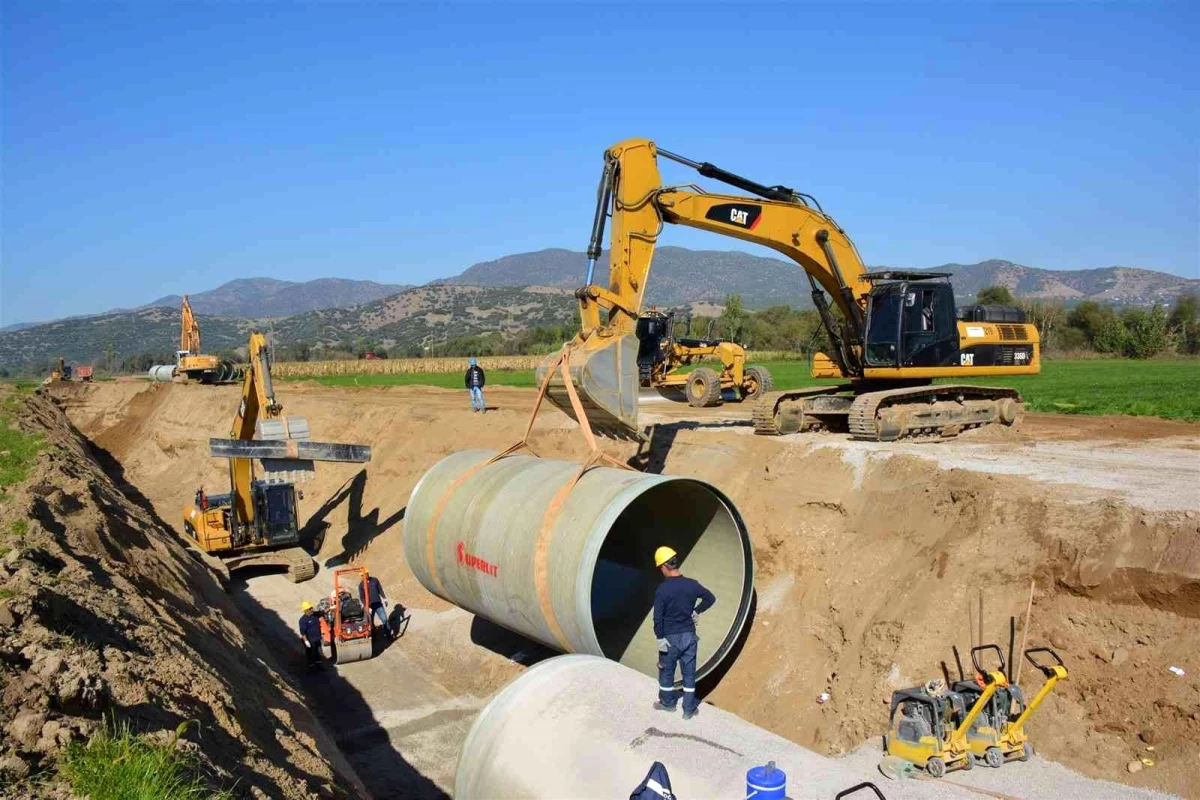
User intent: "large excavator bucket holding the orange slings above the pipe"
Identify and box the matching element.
[538,336,641,439]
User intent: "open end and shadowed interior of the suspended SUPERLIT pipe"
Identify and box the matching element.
[592,480,750,675]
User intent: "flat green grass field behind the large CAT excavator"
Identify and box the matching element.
[283,359,1200,422]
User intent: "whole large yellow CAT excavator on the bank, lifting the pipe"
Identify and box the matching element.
[539,139,1040,441]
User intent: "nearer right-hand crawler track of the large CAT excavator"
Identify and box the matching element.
[848,385,1021,441]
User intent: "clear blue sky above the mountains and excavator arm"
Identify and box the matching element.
[0,0,1200,325]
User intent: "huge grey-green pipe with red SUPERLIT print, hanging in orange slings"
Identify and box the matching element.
[404,450,754,676]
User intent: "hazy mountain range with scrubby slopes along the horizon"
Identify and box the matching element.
[0,246,1200,369]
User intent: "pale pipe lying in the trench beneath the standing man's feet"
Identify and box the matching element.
[454,655,962,800]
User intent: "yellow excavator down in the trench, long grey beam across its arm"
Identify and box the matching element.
[184,331,371,583]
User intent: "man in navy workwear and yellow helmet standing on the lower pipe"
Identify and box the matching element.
[654,547,716,720]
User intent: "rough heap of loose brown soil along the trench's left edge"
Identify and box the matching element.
[0,388,358,798]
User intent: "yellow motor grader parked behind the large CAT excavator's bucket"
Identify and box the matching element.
[637,308,772,408]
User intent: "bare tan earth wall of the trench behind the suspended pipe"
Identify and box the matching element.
[62,384,1200,796]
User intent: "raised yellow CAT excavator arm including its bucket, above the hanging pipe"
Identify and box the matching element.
[539,139,871,437]
